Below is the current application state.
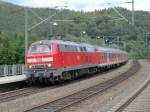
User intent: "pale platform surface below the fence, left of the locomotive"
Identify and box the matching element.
[0,75,27,84]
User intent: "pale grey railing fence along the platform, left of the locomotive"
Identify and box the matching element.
[0,64,25,77]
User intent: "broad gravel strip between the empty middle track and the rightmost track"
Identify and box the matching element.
[63,60,150,112]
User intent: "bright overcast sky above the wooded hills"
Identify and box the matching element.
[3,0,150,11]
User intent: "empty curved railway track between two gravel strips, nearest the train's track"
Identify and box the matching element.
[25,61,141,112]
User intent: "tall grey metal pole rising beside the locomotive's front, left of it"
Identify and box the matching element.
[25,8,28,65]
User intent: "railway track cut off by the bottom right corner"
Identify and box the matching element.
[108,62,150,112]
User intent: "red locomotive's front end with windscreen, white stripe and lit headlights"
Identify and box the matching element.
[26,40,60,81]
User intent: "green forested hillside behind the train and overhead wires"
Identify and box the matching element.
[0,2,150,64]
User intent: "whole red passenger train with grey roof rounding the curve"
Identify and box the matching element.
[26,40,128,84]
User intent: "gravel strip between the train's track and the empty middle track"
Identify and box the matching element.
[0,61,132,112]
